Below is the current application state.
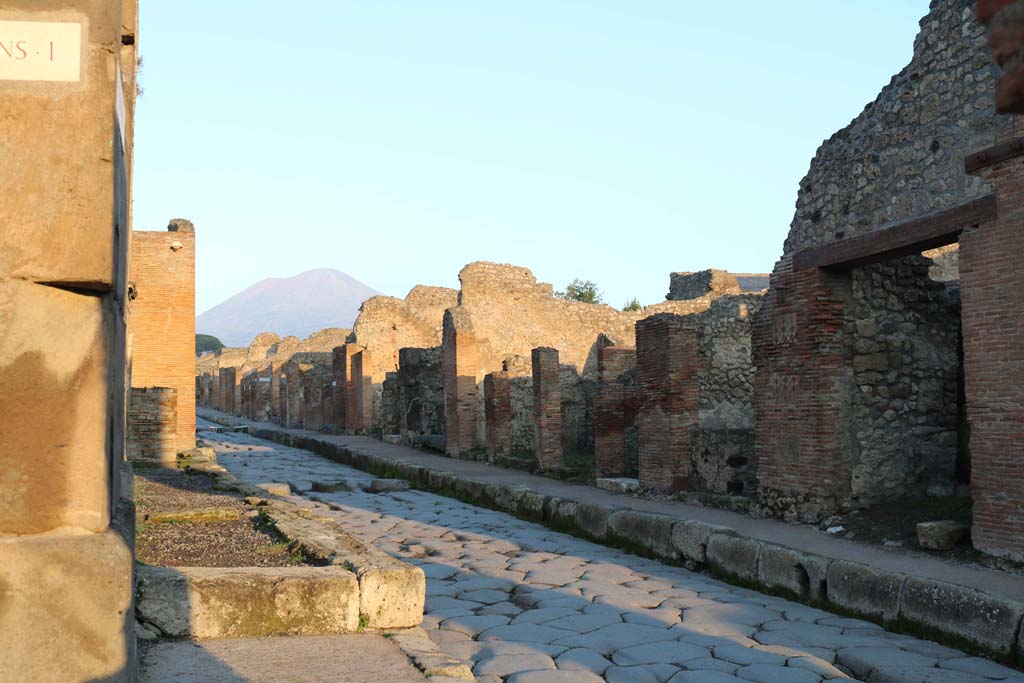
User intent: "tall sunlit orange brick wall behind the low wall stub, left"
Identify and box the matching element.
[128,220,196,451]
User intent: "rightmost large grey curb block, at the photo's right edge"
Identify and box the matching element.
[899,577,1024,655]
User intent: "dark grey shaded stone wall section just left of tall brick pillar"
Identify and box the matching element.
[398,346,444,445]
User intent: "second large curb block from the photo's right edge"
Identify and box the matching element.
[827,560,907,622]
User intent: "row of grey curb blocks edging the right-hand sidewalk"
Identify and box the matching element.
[207,416,1024,667]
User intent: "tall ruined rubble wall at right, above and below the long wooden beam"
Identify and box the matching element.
[757,0,1015,518]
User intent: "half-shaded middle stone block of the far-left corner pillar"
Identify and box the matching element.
[0,278,113,533]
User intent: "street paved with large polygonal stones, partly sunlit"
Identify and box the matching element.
[201,420,1024,683]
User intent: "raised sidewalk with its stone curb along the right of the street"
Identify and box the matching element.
[201,411,1024,666]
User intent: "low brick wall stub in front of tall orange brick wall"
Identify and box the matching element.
[127,387,179,465]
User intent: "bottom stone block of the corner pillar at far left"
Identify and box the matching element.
[0,530,135,683]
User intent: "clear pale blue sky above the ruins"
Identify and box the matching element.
[135,0,928,311]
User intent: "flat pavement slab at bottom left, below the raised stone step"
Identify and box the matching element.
[141,634,423,683]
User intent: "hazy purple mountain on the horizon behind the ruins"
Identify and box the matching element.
[196,268,378,346]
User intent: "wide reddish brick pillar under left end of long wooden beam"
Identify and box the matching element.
[753,262,852,521]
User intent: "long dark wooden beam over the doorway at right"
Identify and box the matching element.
[793,195,997,272]
